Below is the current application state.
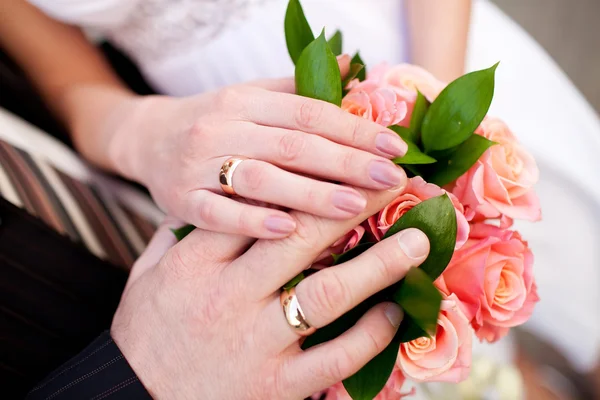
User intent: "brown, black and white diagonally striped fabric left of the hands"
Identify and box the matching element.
[0,140,156,267]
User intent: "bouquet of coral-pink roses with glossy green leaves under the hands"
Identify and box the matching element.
[284,0,541,400]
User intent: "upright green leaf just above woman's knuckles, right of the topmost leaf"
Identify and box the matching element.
[296,31,342,106]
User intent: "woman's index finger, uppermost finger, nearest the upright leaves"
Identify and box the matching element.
[240,89,408,158]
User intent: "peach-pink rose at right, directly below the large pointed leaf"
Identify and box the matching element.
[452,118,541,221]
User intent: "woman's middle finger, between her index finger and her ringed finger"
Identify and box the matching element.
[224,122,405,189]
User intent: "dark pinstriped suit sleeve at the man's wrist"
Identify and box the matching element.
[26,331,152,400]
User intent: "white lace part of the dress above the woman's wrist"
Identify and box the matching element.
[30,0,273,64]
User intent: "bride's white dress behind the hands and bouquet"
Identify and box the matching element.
[30,0,600,376]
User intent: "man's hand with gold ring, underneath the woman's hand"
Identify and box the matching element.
[111,186,429,400]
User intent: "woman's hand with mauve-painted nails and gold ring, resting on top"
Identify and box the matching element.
[112,57,407,238]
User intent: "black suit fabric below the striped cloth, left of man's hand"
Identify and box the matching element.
[0,197,127,399]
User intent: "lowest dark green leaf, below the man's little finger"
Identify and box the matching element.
[344,342,400,400]
